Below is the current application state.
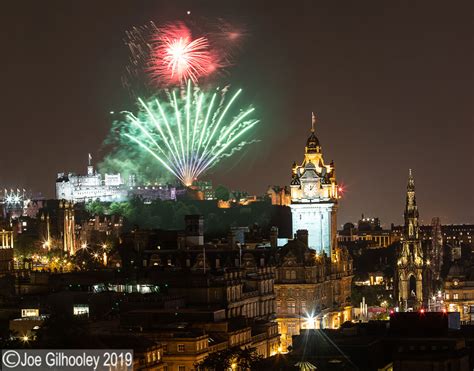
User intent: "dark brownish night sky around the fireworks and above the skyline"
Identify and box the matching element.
[0,0,474,225]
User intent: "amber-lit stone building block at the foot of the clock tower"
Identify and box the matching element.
[275,231,353,351]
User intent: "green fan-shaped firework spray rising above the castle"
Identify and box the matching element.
[118,80,259,186]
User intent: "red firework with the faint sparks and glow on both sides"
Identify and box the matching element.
[122,20,246,91]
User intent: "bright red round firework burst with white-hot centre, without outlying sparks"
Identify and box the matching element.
[150,24,217,83]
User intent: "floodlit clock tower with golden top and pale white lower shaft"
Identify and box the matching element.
[290,114,338,257]
